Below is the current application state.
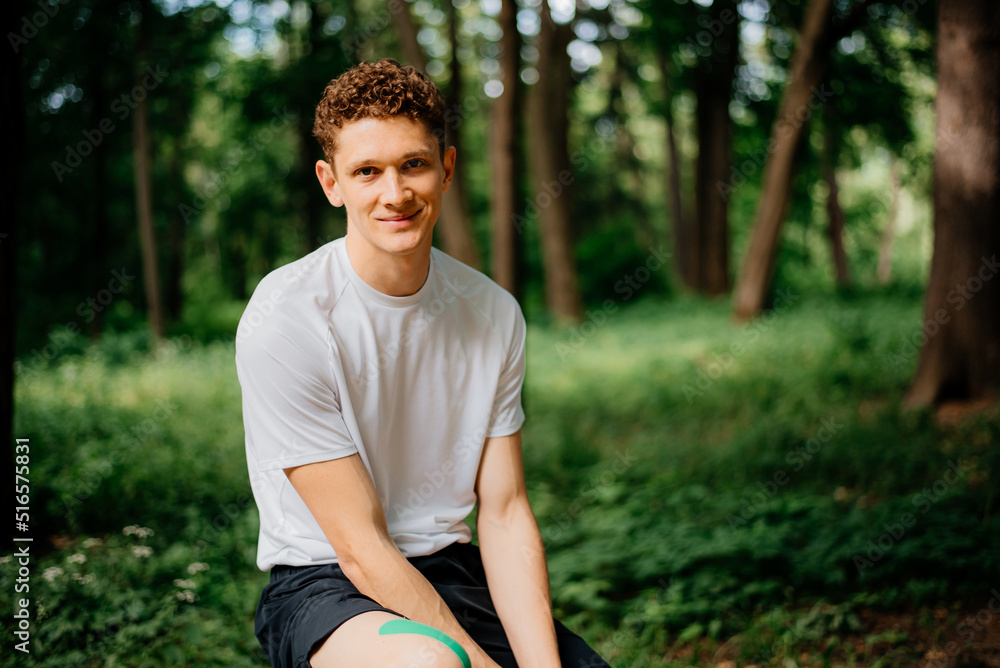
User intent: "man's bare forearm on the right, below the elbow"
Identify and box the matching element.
[477,500,560,668]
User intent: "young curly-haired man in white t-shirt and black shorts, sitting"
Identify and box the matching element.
[236,60,607,668]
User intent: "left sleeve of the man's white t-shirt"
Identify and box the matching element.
[236,331,358,471]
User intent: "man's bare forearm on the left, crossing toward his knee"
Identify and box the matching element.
[341,535,496,668]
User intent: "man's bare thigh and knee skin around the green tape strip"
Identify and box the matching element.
[309,611,462,668]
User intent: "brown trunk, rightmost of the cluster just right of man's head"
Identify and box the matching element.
[529,0,583,321]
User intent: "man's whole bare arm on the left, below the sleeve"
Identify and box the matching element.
[285,454,499,668]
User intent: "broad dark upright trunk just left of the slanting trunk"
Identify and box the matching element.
[692,0,739,295]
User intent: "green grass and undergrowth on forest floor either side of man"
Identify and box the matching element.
[0,295,1000,668]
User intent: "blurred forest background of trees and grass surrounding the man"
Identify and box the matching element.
[0,0,1000,668]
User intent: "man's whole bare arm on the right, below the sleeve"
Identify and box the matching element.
[476,431,560,668]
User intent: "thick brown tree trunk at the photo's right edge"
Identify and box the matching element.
[905,0,1000,408]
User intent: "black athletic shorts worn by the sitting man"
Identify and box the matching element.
[255,543,608,668]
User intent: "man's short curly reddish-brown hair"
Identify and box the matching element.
[313,58,445,165]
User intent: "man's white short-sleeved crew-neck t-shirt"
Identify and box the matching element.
[236,237,525,570]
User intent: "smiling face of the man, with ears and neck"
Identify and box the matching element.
[316,116,455,278]
